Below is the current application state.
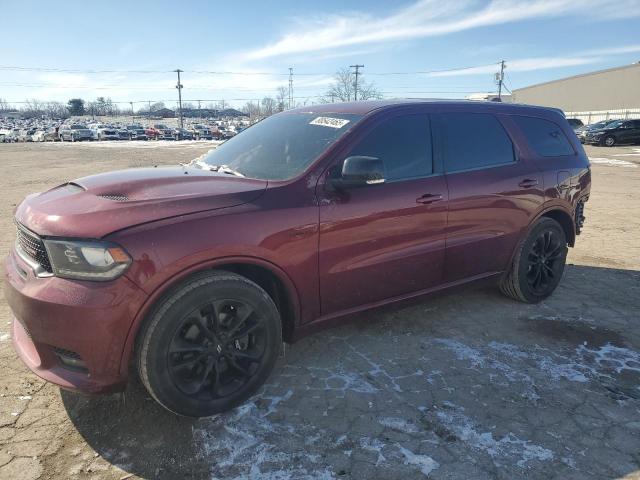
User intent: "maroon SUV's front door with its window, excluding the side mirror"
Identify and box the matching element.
[319,114,448,315]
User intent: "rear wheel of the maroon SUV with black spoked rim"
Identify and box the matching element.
[500,217,568,303]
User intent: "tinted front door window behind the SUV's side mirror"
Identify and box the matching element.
[349,115,433,181]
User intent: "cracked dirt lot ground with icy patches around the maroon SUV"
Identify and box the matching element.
[0,142,640,480]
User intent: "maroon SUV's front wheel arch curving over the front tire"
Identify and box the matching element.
[120,257,300,375]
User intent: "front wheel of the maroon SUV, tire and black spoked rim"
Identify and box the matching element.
[137,271,282,417]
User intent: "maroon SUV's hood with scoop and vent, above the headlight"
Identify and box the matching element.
[16,167,267,238]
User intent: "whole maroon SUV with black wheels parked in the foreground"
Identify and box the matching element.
[5,101,591,416]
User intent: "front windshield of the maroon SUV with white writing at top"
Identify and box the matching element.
[197,113,361,180]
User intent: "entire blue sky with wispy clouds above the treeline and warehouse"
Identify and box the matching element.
[0,0,640,109]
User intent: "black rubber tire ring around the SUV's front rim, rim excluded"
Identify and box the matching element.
[140,275,282,417]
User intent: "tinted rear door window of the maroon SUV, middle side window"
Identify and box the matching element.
[440,113,515,172]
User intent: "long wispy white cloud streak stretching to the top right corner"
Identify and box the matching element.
[243,0,640,60]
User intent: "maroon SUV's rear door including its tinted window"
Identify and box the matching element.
[434,111,544,282]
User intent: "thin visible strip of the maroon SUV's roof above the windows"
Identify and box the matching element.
[287,98,560,115]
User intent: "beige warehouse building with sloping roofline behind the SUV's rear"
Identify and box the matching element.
[513,62,640,116]
